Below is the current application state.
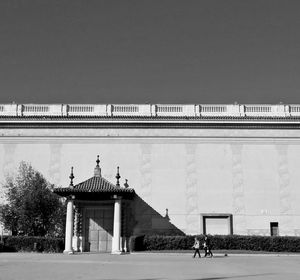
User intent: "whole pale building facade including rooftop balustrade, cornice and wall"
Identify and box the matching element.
[0,104,300,252]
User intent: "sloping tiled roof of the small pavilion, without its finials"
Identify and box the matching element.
[54,177,134,194]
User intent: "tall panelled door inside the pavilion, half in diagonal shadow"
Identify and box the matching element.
[85,207,113,252]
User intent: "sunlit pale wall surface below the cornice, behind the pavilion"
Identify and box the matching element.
[0,128,300,235]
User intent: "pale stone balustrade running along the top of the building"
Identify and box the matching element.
[0,104,300,118]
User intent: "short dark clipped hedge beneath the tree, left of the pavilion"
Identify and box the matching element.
[0,236,64,253]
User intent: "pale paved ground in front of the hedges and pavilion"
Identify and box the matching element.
[0,253,300,280]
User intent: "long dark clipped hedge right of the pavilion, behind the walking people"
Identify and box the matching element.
[130,235,300,252]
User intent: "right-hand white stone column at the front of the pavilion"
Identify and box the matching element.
[111,195,122,254]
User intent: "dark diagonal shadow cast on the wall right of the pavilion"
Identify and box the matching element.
[126,194,185,236]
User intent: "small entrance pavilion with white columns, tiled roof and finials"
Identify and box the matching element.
[54,156,135,254]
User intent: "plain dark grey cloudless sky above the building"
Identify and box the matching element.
[0,0,300,104]
